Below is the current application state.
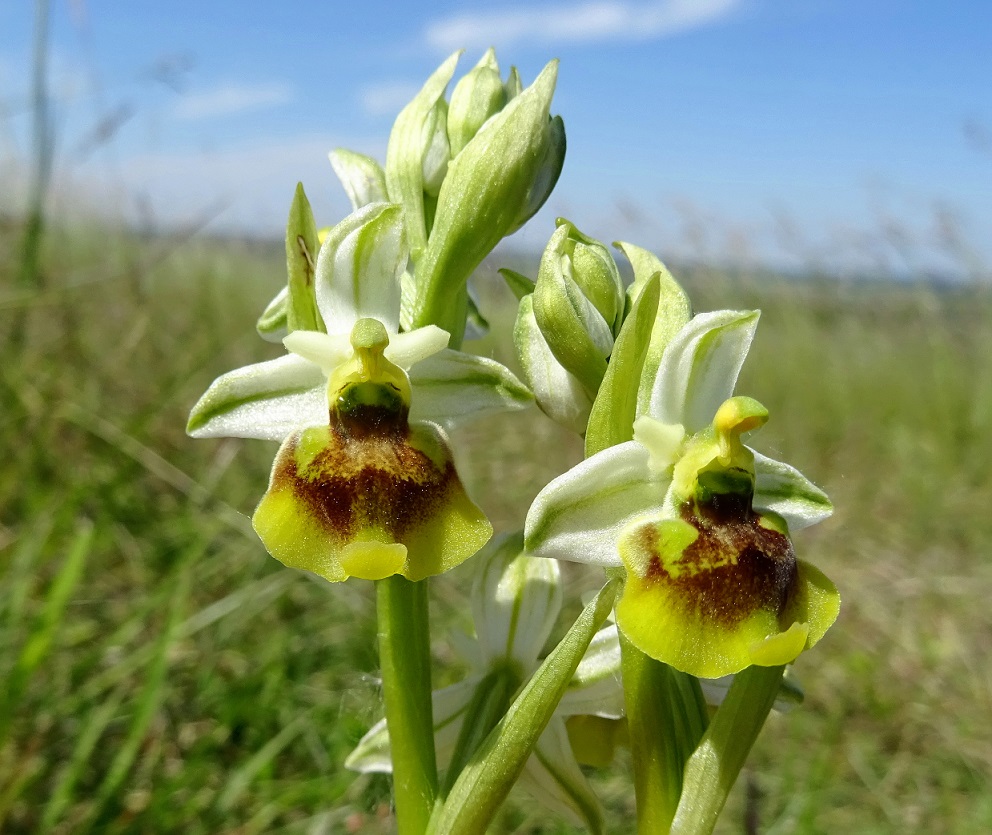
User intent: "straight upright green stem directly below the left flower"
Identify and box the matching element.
[376,575,437,835]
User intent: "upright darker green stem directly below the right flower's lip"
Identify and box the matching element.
[620,632,707,835]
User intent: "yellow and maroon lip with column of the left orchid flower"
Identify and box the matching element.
[252,319,492,582]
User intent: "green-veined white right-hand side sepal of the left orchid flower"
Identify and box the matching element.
[406,348,534,427]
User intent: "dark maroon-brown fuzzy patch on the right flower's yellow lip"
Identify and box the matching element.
[636,495,797,627]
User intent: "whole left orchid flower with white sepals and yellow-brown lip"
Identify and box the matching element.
[187,202,532,582]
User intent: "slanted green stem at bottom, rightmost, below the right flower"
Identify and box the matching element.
[672,666,785,835]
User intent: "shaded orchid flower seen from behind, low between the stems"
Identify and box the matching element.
[345,534,623,832]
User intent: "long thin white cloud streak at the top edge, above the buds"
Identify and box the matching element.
[424,0,741,50]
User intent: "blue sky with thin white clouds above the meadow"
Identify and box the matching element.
[0,0,992,269]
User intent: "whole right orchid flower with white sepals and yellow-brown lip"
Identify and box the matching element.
[525,311,840,678]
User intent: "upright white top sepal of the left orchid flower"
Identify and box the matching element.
[316,203,408,334]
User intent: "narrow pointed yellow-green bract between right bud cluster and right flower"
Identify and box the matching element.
[586,276,659,458]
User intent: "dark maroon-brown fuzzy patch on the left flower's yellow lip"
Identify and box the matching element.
[272,414,459,542]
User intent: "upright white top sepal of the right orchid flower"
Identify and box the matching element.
[648,310,759,435]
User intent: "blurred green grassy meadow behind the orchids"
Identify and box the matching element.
[0,217,992,833]
